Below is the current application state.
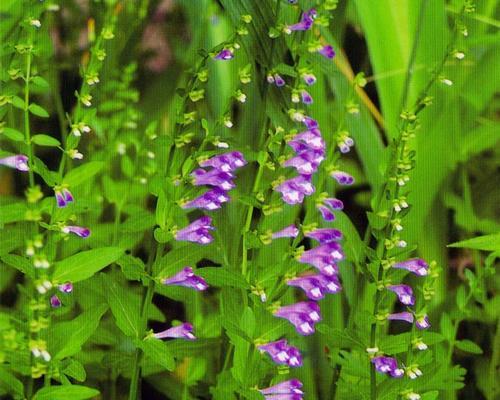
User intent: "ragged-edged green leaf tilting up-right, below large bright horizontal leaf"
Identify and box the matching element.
[53,304,108,360]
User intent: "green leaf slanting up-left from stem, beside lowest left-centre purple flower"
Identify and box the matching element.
[101,274,140,338]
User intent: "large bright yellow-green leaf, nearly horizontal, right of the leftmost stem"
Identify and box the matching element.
[53,247,123,282]
